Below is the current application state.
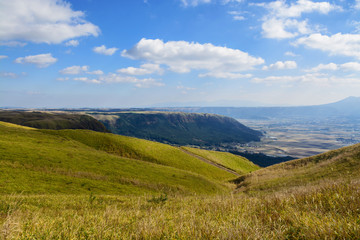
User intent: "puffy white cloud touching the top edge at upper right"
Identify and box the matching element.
[257,0,340,39]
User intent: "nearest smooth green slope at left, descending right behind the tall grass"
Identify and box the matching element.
[0,122,228,195]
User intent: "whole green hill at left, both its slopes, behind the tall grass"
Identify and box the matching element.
[0,122,256,195]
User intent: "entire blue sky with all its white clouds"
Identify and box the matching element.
[0,0,360,108]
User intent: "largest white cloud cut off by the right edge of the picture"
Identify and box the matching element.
[295,33,360,59]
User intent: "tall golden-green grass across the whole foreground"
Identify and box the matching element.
[0,181,360,239]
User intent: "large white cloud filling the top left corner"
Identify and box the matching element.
[0,0,100,44]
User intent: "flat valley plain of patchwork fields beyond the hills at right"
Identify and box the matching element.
[238,119,360,158]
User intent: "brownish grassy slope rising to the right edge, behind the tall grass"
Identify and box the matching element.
[238,144,360,191]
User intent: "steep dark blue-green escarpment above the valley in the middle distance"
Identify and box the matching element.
[93,112,262,146]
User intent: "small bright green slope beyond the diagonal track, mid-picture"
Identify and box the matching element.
[182,147,260,174]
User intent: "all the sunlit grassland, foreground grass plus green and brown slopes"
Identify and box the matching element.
[0,122,360,239]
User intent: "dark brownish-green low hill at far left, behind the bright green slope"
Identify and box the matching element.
[0,110,107,132]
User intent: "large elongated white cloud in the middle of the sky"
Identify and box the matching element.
[122,38,264,77]
